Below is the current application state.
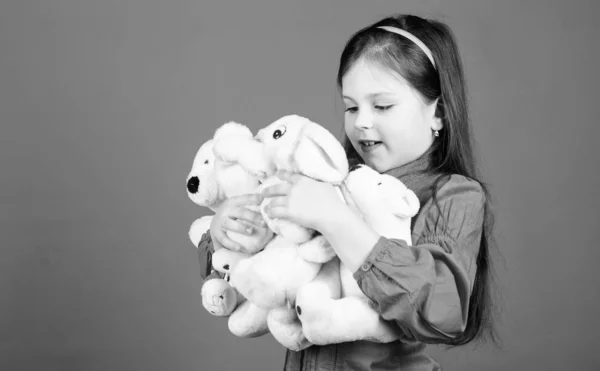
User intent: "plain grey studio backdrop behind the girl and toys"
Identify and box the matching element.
[0,0,600,371]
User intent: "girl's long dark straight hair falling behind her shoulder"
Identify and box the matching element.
[337,15,498,345]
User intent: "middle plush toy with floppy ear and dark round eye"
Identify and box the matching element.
[214,115,348,350]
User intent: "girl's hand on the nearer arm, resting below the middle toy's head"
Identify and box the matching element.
[262,170,344,231]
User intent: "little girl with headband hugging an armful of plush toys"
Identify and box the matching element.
[199,15,494,371]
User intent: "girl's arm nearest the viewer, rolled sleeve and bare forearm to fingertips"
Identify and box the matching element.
[264,173,485,343]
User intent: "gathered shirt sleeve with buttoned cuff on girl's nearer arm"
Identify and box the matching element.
[354,176,485,343]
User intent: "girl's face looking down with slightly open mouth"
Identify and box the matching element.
[342,59,442,173]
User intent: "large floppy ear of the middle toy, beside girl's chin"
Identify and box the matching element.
[293,122,348,183]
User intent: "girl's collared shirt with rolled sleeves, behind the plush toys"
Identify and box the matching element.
[198,156,485,371]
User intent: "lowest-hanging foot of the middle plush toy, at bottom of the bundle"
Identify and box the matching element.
[267,305,312,352]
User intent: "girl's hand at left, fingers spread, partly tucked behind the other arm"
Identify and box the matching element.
[210,194,268,251]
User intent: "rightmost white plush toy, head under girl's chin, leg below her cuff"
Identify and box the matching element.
[296,165,419,345]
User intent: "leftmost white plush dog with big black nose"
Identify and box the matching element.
[187,122,273,337]
